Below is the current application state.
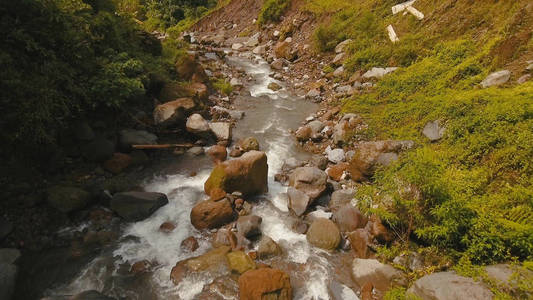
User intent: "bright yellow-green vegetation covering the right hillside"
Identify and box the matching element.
[307,0,533,270]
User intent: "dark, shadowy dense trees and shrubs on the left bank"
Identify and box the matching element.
[0,0,215,170]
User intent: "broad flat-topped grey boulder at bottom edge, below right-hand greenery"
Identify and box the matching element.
[407,272,494,300]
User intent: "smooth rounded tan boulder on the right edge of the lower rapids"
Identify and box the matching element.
[306,218,341,250]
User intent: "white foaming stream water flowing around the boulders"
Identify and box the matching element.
[42,54,358,300]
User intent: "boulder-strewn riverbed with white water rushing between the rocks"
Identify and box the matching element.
[0,25,528,300]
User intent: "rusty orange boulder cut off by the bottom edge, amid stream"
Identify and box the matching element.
[239,268,292,300]
